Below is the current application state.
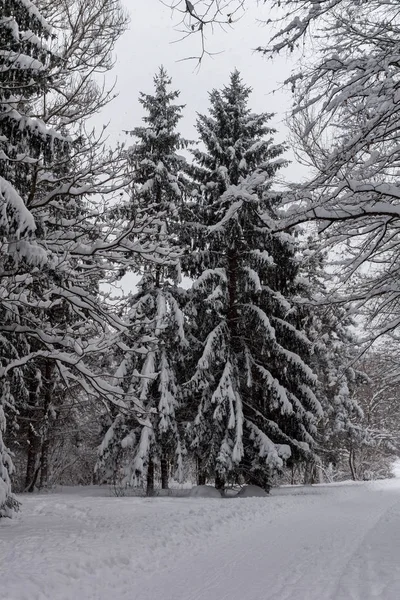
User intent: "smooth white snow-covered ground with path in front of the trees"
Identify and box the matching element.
[0,480,400,600]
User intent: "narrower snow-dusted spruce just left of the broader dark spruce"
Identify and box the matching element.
[97,68,187,494]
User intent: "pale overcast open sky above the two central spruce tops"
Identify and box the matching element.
[99,0,301,179]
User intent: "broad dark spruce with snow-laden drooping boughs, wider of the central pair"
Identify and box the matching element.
[184,71,321,486]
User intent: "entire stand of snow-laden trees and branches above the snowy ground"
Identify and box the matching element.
[0,0,400,516]
